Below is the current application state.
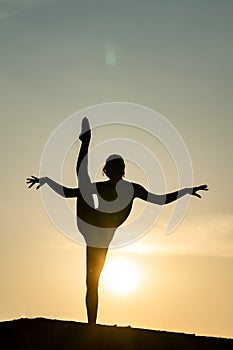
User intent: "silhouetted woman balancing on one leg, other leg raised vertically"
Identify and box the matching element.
[27,118,208,324]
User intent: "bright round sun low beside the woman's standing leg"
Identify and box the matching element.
[102,258,140,294]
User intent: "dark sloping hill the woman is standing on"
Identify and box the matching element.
[0,318,233,350]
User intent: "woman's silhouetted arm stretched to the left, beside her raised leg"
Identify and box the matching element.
[26,176,78,198]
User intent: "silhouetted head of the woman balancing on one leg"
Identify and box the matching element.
[103,154,125,180]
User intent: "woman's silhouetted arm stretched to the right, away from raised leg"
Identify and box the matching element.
[134,184,208,205]
